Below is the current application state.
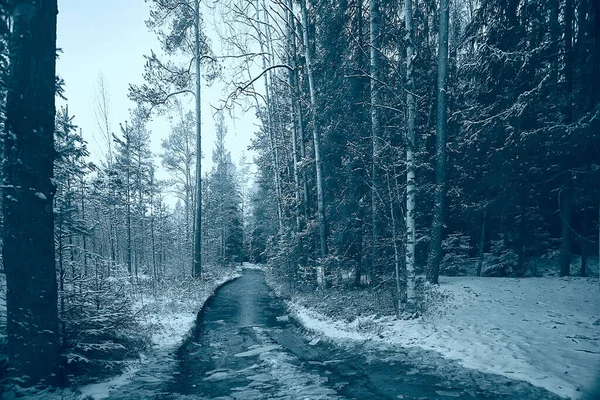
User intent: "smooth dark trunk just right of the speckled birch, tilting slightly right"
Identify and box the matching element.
[427,0,449,283]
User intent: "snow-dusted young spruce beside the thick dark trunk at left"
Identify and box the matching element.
[59,257,148,376]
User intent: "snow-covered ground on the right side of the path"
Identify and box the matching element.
[288,277,600,399]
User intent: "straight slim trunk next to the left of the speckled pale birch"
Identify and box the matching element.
[369,0,381,282]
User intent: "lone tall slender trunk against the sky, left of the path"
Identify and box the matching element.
[194,0,202,278]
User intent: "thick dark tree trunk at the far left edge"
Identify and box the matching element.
[3,0,59,383]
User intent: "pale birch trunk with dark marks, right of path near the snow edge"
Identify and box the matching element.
[404,0,417,312]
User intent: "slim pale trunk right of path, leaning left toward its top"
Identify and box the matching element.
[300,0,328,272]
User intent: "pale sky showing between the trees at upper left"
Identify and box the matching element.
[57,0,260,202]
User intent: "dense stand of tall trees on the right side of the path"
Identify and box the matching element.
[239,0,600,304]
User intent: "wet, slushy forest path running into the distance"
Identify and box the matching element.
[104,269,555,400]
